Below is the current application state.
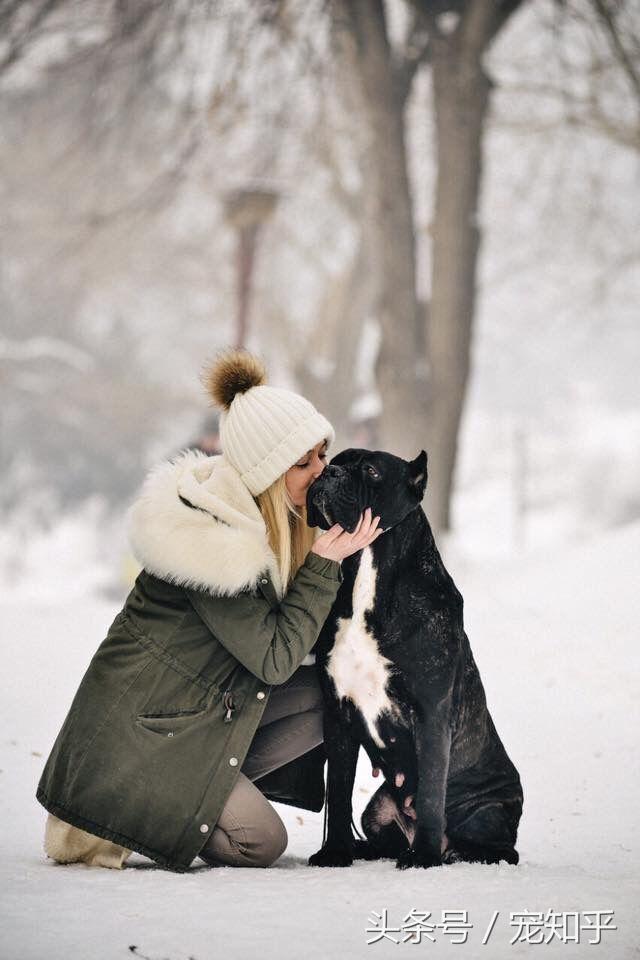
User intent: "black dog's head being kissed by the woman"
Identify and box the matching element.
[307,447,427,533]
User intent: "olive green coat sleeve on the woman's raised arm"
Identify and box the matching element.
[187,552,343,684]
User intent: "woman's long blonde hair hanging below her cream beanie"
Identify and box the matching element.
[256,474,316,593]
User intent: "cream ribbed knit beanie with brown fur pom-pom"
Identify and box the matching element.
[204,350,335,497]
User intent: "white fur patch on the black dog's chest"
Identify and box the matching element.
[327,547,395,747]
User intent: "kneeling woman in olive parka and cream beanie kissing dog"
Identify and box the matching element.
[37,351,382,871]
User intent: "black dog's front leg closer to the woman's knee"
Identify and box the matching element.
[309,705,360,867]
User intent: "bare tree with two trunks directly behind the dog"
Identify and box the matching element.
[332,0,520,529]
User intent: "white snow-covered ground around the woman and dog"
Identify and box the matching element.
[0,524,640,960]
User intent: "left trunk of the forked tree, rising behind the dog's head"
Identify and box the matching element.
[333,0,427,458]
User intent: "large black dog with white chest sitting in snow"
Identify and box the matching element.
[307,449,522,868]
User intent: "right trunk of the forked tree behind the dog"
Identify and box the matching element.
[427,0,496,530]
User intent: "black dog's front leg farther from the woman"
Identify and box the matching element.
[396,715,451,870]
